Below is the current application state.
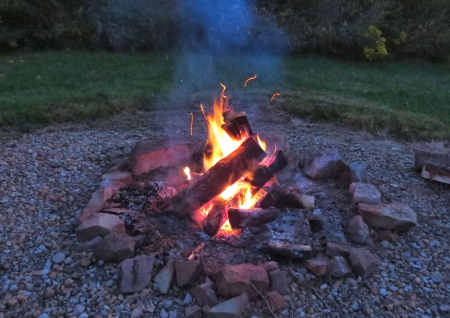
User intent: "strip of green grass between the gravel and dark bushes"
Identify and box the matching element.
[0,52,450,139]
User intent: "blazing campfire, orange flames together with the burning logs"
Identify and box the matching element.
[169,92,287,236]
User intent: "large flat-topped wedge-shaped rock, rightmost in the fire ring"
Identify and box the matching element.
[358,203,417,231]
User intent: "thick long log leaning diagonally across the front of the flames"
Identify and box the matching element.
[169,138,267,217]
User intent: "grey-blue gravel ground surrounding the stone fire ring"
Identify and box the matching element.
[0,109,450,318]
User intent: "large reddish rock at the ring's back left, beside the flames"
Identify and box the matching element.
[129,138,194,175]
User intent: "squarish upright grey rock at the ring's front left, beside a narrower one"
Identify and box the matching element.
[120,254,155,293]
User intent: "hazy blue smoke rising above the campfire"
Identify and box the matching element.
[174,0,287,102]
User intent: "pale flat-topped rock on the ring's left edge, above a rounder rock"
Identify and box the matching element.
[77,213,126,242]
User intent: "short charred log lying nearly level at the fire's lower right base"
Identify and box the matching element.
[228,209,281,229]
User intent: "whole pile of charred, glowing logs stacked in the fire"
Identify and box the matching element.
[169,111,302,236]
